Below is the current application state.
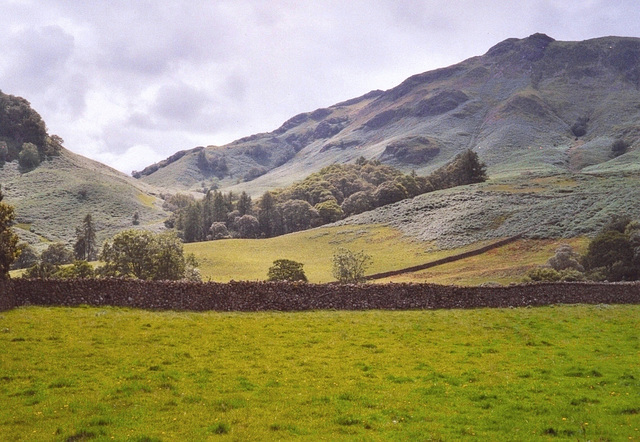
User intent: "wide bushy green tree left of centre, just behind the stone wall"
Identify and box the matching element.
[100,230,191,280]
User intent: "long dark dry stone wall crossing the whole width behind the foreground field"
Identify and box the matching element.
[0,279,640,312]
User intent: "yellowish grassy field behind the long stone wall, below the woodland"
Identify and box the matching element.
[185,225,587,285]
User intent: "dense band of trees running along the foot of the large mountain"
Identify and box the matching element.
[164,150,487,242]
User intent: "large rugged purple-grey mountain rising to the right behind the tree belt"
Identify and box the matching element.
[134,34,640,195]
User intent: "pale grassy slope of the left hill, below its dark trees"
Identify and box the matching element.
[0,148,167,247]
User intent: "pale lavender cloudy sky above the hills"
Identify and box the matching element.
[0,0,640,173]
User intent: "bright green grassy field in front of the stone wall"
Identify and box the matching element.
[0,305,640,441]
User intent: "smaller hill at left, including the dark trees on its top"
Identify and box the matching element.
[0,91,167,249]
